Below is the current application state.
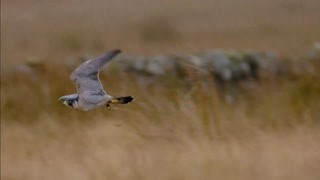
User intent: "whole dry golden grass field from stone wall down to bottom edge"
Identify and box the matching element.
[1,61,320,179]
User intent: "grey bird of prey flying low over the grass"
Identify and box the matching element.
[59,49,134,111]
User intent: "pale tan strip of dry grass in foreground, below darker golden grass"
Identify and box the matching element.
[1,119,320,179]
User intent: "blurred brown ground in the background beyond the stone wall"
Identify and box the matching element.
[1,0,320,65]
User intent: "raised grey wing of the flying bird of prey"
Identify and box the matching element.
[70,49,121,95]
